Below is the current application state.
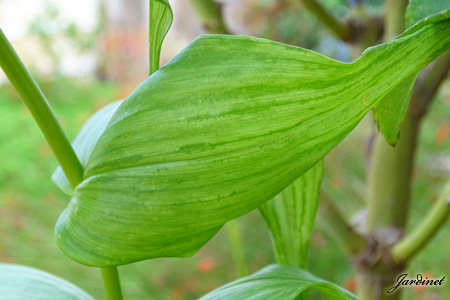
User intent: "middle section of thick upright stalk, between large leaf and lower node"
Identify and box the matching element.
[366,112,418,231]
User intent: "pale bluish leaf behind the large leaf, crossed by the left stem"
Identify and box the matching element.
[52,101,122,195]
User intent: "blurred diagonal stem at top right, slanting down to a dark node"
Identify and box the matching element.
[302,0,350,41]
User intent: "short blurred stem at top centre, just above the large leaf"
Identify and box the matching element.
[191,0,228,34]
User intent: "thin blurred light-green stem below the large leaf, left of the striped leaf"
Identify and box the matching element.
[225,220,248,278]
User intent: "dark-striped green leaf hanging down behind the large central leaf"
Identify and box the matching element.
[260,161,323,268]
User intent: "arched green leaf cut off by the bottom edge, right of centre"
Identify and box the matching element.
[200,265,359,300]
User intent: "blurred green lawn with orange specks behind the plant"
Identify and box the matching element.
[0,77,450,300]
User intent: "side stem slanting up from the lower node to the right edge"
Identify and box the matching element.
[392,182,450,263]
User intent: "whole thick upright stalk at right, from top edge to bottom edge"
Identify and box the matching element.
[358,0,408,300]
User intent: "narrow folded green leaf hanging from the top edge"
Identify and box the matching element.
[148,0,173,75]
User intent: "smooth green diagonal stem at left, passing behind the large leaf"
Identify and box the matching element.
[0,28,122,300]
